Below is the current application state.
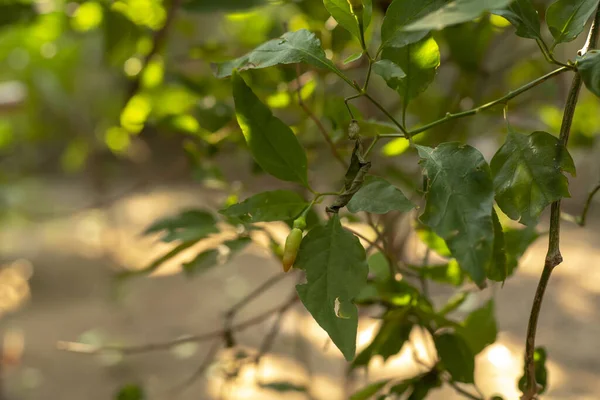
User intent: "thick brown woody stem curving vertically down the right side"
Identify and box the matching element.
[521,8,600,400]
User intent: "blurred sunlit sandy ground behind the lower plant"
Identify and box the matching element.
[0,170,600,400]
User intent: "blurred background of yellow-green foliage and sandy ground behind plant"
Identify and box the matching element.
[0,0,600,400]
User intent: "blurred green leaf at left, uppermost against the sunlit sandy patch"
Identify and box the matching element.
[144,210,219,243]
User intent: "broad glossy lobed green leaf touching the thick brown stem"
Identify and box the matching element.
[490,130,575,225]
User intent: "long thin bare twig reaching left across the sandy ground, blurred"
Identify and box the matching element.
[56,295,298,355]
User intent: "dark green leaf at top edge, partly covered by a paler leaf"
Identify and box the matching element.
[381,0,445,48]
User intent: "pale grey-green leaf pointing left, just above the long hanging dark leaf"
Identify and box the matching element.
[216,29,351,83]
